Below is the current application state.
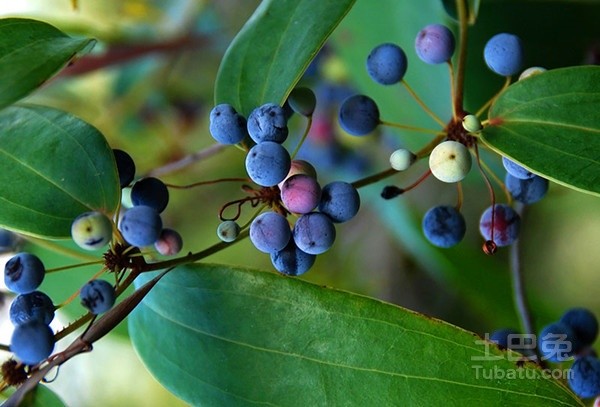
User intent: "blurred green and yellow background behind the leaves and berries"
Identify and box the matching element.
[0,0,600,406]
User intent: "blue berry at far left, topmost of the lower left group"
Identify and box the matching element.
[4,252,46,294]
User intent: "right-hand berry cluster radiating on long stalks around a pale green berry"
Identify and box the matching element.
[332,24,548,254]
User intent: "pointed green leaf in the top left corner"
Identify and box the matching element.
[0,18,94,108]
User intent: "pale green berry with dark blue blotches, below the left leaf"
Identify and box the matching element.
[71,211,113,250]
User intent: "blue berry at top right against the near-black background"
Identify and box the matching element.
[483,33,523,76]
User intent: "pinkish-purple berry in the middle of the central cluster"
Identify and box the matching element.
[281,174,321,213]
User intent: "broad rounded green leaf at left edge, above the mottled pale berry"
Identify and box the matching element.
[0,105,120,238]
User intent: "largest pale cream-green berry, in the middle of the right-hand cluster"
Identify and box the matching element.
[429,140,471,183]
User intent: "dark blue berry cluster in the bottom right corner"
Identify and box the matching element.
[490,307,600,398]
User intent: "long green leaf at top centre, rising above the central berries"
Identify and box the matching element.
[215,0,355,115]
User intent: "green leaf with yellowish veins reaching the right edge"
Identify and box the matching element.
[482,66,600,195]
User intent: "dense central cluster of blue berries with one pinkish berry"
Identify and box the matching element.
[210,91,360,276]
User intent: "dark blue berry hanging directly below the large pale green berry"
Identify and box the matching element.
[422,206,467,248]
